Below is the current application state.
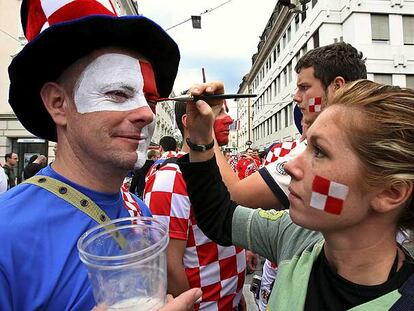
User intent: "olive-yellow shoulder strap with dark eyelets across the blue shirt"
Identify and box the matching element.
[23,175,126,249]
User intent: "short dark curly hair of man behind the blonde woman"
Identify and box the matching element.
[295,42,367,88]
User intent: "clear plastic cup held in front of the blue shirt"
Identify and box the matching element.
[78,217,169,311]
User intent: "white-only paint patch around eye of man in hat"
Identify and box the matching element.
[74,53,148,113]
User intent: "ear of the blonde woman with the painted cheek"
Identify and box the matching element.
[371,181,413,213]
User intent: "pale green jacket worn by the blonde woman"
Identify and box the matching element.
[232,206,401,311]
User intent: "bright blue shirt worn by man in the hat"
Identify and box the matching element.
[0,166,150,311]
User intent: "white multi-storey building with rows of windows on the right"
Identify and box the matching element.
[238,0,414,150]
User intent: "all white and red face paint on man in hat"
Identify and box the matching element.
[74,53,159,168]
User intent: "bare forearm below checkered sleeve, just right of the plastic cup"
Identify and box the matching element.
[167,239,190,297]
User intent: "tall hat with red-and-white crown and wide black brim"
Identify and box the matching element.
[9,0,180,141]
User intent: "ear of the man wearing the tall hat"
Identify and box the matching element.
[40,82,68,125]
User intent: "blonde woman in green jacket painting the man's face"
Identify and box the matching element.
[180,80,414,311]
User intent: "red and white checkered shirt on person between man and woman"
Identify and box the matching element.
[144,163,246,310]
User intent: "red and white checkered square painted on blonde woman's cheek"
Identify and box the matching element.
[310,176,349,215]
